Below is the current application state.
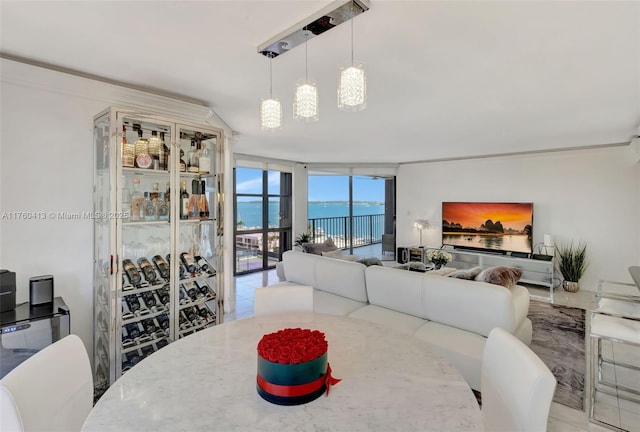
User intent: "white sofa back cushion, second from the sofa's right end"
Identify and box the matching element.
[365,266,427,318]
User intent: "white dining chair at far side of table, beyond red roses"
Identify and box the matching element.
[253,285,313,316]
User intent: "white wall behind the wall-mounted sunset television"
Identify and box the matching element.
[397,146,640,291]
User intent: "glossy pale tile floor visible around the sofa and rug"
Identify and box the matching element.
[224,245,640,432]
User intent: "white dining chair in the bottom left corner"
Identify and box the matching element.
[0,335,93,432]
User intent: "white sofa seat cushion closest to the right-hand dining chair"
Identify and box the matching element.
[414,321,487,391]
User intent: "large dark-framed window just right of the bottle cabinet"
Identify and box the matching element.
[234,167,292,274]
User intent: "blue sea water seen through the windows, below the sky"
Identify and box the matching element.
[238,201,384,228]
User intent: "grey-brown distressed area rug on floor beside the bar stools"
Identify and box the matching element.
[528,300,586,411]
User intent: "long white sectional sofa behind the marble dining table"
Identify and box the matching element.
[277,251,532,390]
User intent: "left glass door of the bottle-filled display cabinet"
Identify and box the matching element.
[116,115,175,376]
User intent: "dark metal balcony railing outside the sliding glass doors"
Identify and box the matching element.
[308,214,384,249]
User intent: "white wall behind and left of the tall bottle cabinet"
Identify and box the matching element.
[0,59,233,360]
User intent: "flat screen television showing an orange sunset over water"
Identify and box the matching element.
[442,202,533,255]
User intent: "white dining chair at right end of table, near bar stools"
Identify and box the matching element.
[481,327,556,432]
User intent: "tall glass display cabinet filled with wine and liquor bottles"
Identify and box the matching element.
[91,107,224,395]
